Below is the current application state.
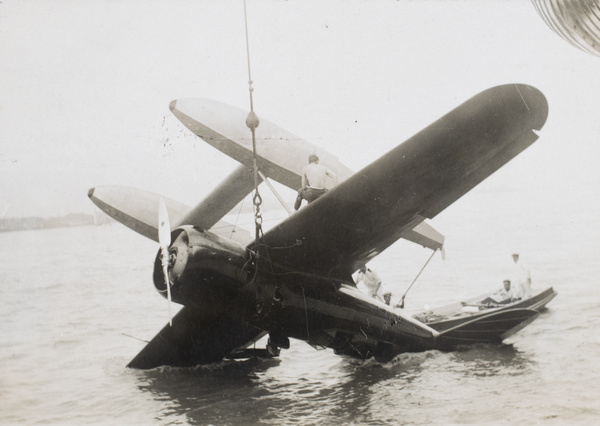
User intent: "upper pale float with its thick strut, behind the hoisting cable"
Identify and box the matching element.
[169,98,444,249]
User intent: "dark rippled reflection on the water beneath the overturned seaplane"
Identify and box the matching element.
[136,342,532,424]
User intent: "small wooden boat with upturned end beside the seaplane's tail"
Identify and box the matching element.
[413,287,557,349]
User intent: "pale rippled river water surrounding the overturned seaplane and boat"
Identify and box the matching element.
[0,187,600,425]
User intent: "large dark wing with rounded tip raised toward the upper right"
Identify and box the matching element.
[251,84,548,280]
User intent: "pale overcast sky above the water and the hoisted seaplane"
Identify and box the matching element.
[0,0,600,217]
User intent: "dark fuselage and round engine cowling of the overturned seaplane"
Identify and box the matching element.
[154,226,433,359]
